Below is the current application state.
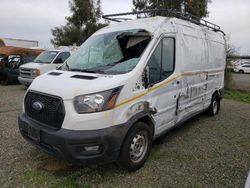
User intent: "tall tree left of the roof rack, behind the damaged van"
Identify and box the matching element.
[51,0,106,46]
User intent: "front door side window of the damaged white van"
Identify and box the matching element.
[148,38,175,85]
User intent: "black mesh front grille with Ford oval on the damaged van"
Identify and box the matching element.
[25,92,65,129]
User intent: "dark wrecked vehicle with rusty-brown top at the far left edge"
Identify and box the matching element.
[0,46,43,85]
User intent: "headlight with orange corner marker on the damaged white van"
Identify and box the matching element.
[74,87,122,114]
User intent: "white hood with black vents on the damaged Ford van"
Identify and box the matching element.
[29,70,128,100]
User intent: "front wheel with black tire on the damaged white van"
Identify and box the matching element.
[116,122,153,172]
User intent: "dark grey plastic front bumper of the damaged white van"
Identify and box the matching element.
[18,113,128,164]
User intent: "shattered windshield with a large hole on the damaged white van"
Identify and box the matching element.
[61,30,151,74]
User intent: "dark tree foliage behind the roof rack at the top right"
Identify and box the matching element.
[133,0,211,18]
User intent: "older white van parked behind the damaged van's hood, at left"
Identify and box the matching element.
[18,49,71,86]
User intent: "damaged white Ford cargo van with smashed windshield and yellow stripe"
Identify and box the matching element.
[19,10,226,171]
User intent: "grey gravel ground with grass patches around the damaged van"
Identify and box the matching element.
[0,86,250,188]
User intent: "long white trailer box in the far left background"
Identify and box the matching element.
[0,38,38,48]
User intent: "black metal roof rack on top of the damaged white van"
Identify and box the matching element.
[102,9,225,35]
